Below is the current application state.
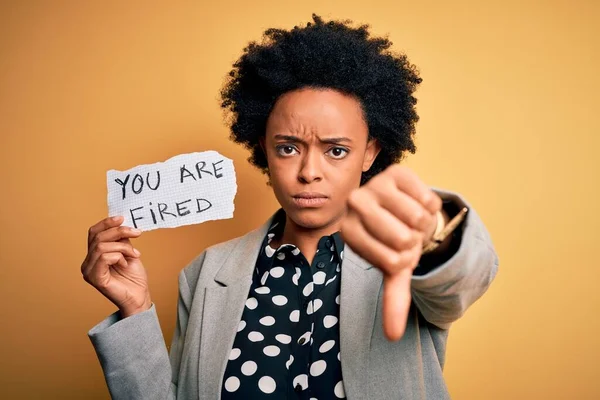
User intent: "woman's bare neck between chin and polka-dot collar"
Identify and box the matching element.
[272,212,342,264]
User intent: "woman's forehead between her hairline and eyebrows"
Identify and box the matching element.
[267,88,367,137]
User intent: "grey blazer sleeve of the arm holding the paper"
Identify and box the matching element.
[88,252,205,400]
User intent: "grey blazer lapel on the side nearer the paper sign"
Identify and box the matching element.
[198,215,274,399]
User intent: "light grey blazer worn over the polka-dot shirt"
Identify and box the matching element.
[88,188,498,400]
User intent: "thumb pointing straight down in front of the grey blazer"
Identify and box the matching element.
[383,268,412,340]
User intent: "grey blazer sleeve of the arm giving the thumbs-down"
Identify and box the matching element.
[411,188,499,329]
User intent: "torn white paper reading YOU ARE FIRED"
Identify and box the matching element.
[106,150,237,231]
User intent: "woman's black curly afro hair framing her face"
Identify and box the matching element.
[220,14,422,185]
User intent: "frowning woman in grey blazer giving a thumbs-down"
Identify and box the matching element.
[82,15,498,400]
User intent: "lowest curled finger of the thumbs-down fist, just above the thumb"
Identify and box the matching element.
[341,211,422,274]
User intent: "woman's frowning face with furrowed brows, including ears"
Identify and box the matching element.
[261,88,379,229]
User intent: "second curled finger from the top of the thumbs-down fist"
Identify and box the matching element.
[369,184,435,232]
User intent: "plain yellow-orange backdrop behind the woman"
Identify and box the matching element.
[0,0,600,399]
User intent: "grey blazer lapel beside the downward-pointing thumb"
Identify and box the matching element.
[340,246,383,399]
